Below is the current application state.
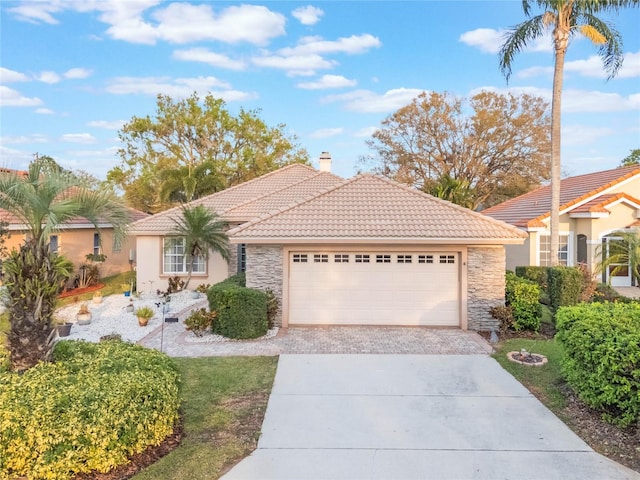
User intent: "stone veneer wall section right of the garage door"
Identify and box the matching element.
[467,247,506,331]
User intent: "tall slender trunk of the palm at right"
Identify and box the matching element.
[550,32,568,267]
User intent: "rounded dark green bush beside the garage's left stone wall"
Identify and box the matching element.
[207,275,269,338]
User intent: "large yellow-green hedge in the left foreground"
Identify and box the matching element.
[0,341,179,480]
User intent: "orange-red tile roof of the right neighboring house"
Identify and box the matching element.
[482,165,640,228]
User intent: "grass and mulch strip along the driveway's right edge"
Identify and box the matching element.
[493,338,640,472]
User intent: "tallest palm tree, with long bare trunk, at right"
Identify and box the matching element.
[500,0,640,266]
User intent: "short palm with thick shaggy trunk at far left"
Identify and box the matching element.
[0,160,129,371]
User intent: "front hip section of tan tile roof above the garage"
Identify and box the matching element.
[229,174,526,244]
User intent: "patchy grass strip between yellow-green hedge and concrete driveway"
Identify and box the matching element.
[133,357,278,480]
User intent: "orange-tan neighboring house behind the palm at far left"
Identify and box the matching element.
[0,205,149,277]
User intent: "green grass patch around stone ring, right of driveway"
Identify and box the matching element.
[493,338,566,419]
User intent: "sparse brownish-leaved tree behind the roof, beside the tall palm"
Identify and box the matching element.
[361,92,550,208]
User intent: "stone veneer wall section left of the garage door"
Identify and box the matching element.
[246,245,283,326]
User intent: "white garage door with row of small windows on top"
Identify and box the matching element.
[289,252,460,326]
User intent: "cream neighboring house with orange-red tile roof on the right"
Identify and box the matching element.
[482,165,640,286]
